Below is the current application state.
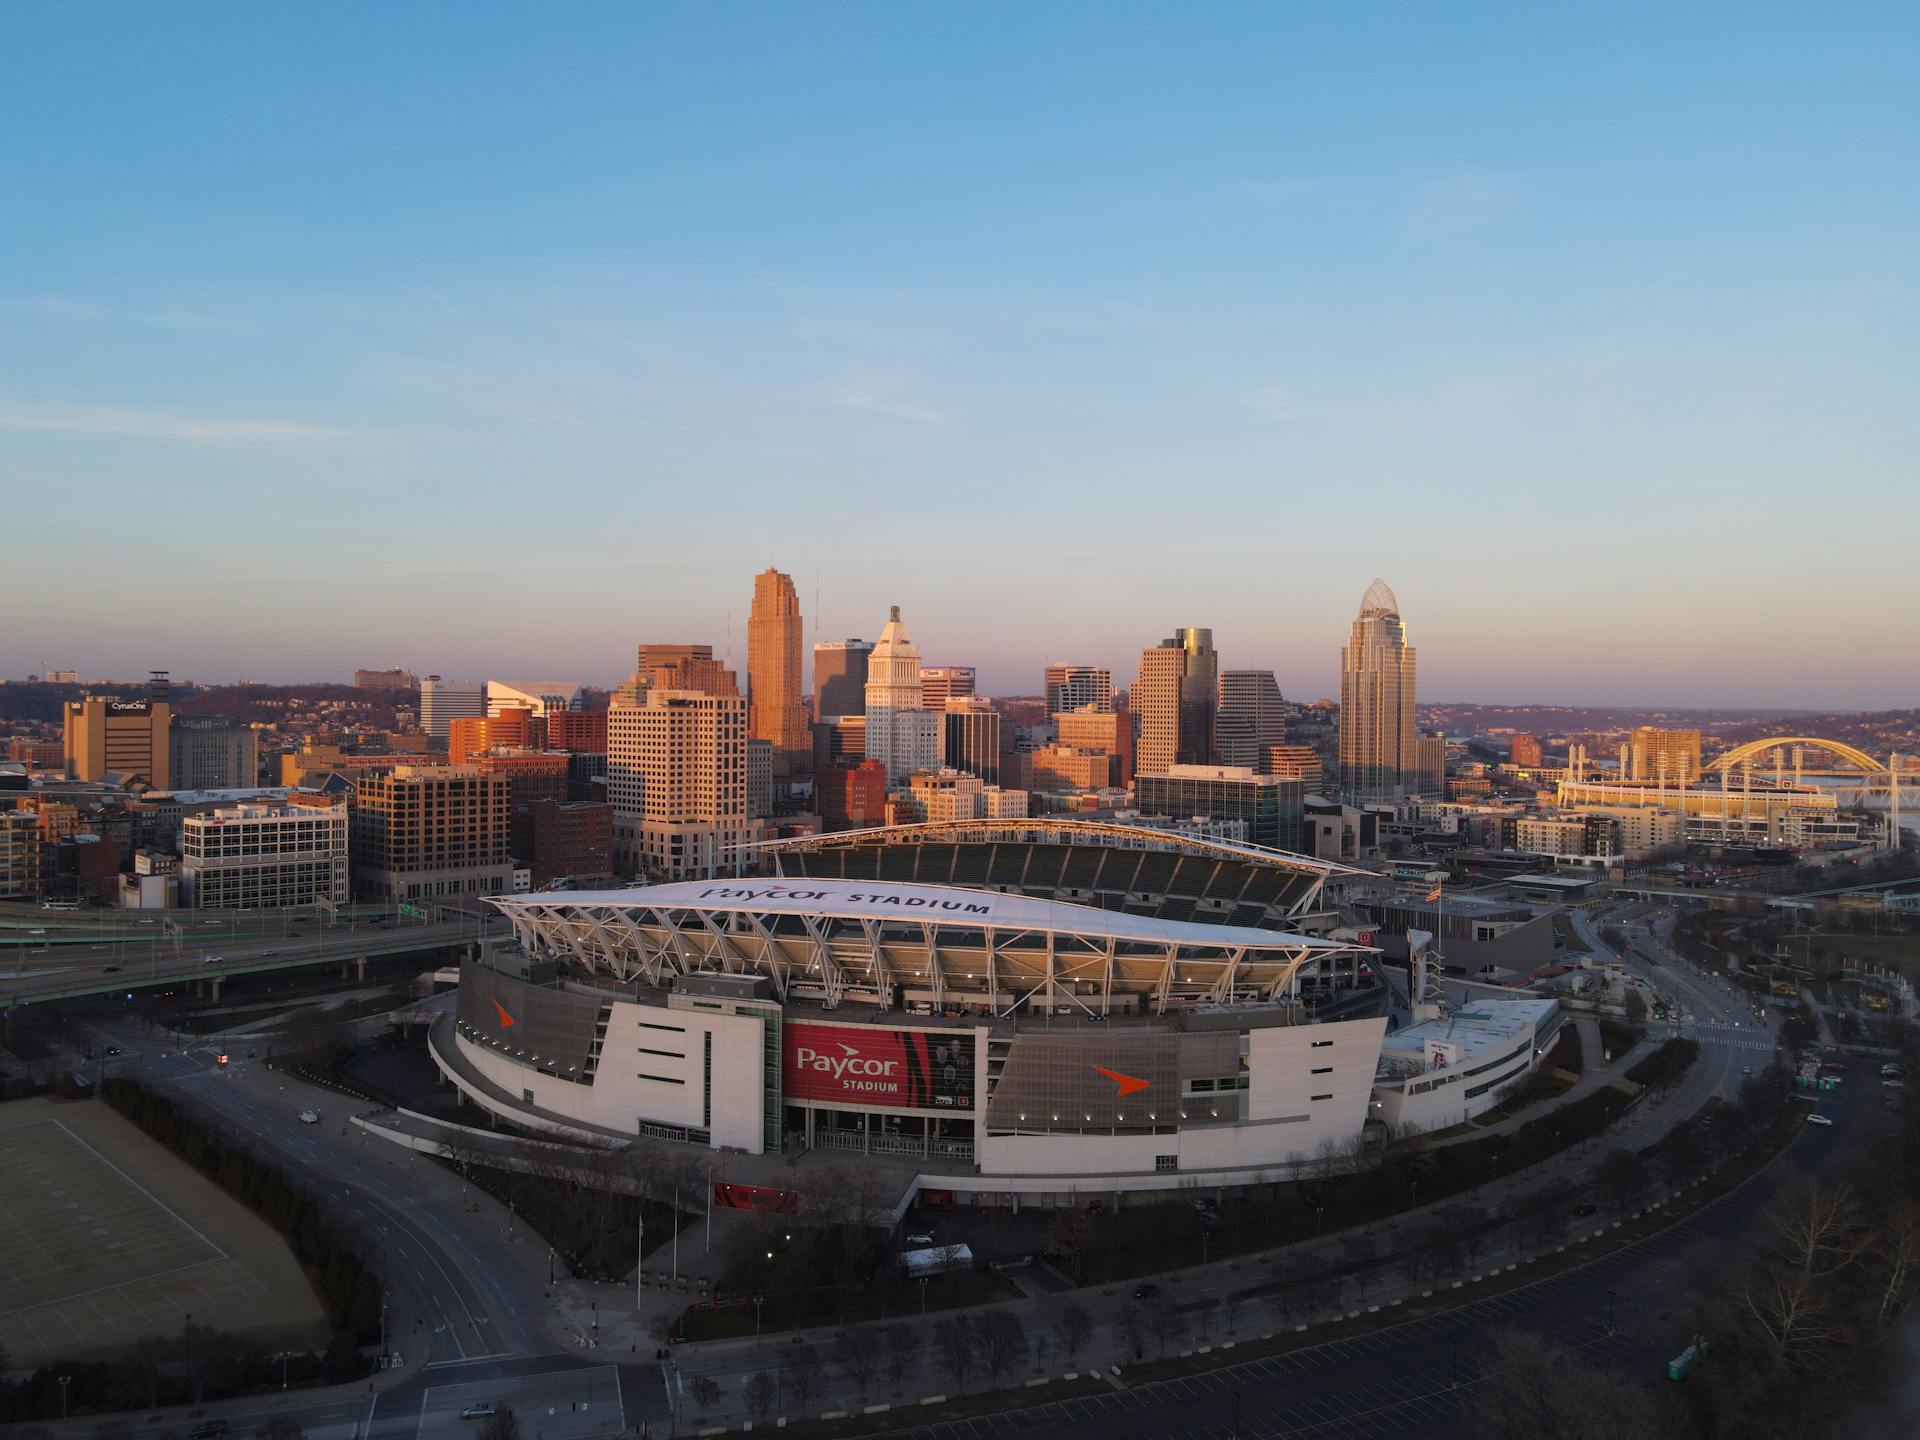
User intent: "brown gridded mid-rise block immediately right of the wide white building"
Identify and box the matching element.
[348,764,513,900]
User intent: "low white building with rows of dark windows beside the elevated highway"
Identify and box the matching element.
[180,795,348,910]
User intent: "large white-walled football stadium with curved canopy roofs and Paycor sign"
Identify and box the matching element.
[430,820,1420,1204]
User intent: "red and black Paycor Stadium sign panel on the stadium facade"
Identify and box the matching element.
[780,1021,973,1110]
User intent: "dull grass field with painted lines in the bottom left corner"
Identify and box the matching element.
[0,1100,326,1365]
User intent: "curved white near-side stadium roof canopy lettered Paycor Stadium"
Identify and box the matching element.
[492,877,1356,950]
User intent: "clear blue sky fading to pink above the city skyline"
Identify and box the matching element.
[0,4,1920,707]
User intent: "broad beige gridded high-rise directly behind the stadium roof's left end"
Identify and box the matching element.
[607,685,756,879]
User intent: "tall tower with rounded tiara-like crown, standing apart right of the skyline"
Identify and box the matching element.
[1340,580,1419,804]
